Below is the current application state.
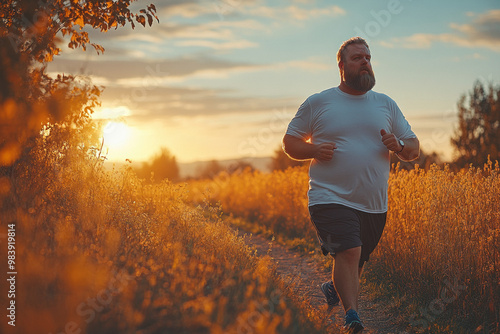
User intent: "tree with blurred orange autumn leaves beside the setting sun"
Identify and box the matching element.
[0,0,158,166]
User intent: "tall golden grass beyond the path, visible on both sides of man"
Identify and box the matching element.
[189,164,500,333]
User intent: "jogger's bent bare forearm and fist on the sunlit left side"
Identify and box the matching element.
[283,134,337,161]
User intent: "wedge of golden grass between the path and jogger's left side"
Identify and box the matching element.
[188,166,315,238]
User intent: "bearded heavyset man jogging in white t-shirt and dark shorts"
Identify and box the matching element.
[283,37,420,333]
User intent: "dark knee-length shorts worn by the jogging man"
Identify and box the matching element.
[309,204,387,267]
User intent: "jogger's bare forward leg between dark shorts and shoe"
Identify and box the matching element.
[333,247,361,312]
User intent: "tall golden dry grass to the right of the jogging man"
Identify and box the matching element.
[375,163,500,333]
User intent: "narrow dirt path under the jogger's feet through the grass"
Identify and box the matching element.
[239,231,405,334]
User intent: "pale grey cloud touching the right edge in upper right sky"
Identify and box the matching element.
[381,9,500,52]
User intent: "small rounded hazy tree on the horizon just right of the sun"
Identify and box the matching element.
[137,147,179,182]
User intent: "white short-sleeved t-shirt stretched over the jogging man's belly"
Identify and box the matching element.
[286,87,416,213]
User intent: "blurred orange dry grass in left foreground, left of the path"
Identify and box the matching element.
[0,142,319,334]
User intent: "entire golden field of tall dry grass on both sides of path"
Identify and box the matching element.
[0,134,500,334]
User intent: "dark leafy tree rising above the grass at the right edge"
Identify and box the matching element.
[451,81,500,167]
